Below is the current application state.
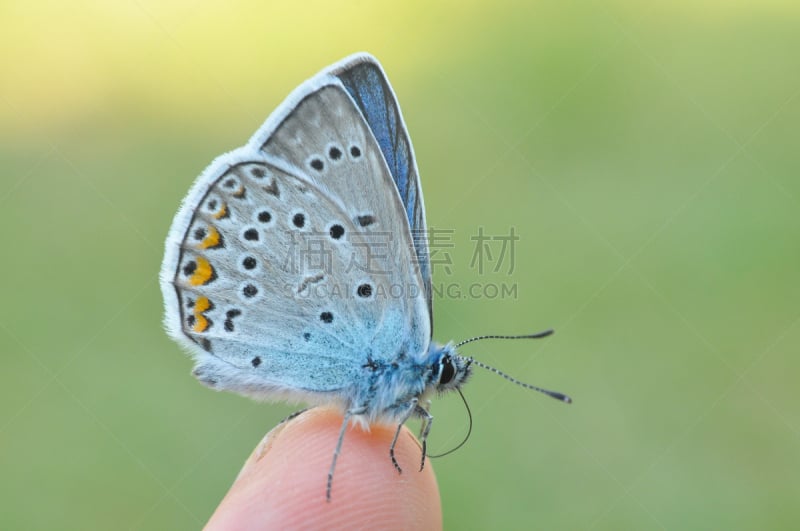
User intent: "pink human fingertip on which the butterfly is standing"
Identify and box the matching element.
[206,408,442,530]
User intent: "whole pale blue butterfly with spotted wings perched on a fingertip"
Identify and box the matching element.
[160,53,570,500]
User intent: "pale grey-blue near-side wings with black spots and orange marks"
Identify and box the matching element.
[161,64,430,403]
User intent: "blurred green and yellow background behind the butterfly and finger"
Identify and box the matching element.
[0,0,800,529]
